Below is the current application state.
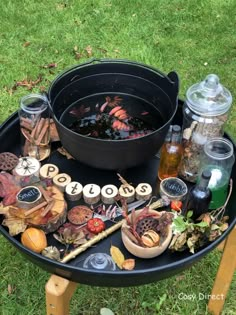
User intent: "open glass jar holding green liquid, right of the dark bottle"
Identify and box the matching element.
[199,137,235,209]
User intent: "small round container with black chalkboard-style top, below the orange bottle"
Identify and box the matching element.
[160,177,188,200]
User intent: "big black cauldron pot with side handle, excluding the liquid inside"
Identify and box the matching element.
[48,59,179,170]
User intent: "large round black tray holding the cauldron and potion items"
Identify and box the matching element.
[0,110,236,287]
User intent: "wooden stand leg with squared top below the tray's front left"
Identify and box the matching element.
[45,275,77,315]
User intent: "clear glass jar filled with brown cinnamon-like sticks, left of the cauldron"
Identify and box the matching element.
[19,94,50,161]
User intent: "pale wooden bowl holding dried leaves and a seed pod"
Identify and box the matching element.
[121,210,172,259]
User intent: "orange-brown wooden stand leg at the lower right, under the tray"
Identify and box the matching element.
[208,227,236,315]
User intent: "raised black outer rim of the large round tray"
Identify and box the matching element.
[0,112,236,287]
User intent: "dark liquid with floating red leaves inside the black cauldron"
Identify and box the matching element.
[60,93,164,140]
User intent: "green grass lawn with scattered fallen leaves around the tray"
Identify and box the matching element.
[0,0,236,315]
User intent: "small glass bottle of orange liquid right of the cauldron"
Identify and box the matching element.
[158,125,183,180]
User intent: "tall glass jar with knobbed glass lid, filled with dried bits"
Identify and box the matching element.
[179,74,232,183]
